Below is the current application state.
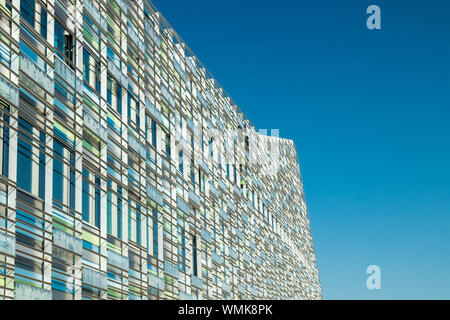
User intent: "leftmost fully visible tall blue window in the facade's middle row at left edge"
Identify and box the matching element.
[17,116,45,199]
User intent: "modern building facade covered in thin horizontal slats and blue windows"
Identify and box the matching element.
[0,0,322,299]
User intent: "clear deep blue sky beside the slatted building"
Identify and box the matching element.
[153,0,450,299]
